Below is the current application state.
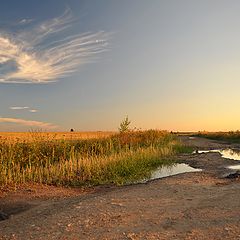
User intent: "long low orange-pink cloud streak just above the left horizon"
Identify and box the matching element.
[0,117,58,129]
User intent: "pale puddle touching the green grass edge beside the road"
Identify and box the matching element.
[147,163,202,180]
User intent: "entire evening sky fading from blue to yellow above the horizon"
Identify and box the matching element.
[0,0,240,131]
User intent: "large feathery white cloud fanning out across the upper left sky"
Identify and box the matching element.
[0,10,109,83]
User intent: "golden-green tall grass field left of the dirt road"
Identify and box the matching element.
[0,130,188,186]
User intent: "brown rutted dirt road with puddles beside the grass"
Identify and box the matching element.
[0,136,240,240]
